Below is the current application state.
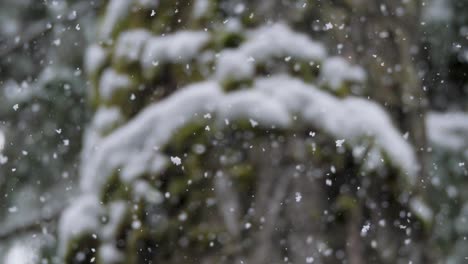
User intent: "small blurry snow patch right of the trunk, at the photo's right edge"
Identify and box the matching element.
[426,112,468,151]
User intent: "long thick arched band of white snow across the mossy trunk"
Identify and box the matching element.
[81,75,418,192]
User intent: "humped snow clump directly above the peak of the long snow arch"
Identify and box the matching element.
[216,23,327,80]
